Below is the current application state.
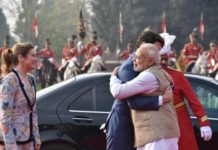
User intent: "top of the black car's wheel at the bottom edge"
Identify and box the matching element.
[40,141,78,150]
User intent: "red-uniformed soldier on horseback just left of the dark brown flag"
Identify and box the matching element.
[62,38,78,65]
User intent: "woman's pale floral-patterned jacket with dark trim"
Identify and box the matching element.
[0,73,41,149]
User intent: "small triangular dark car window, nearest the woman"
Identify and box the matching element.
[69,89,94,111]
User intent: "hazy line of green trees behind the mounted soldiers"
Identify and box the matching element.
[11,0,218,59]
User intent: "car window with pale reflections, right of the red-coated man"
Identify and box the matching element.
[188,82,218,117]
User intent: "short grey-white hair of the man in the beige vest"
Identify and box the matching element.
[140,43,161,64]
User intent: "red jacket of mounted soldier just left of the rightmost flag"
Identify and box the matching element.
[182,43,203,65]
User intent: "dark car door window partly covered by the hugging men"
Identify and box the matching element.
[96,82,114,111]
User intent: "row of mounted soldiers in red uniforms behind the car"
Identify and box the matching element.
[0,32,218,85]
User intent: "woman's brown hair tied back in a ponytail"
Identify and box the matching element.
[1,42,33,77]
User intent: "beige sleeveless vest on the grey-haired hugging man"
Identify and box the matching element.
[131,65,180,147]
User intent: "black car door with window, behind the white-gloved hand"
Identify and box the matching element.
[188,78,218,150]
